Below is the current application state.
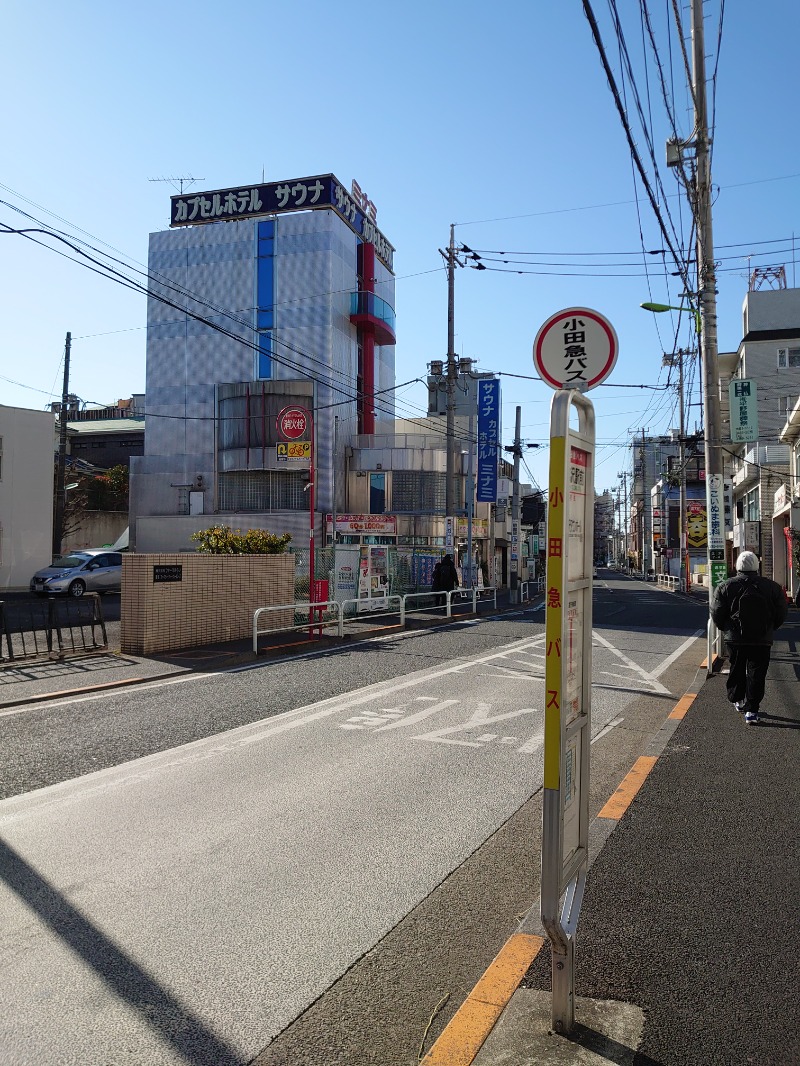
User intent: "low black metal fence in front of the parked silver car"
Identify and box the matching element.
[0,593,109,663]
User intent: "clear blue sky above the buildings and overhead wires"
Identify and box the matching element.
[0,0,800,491]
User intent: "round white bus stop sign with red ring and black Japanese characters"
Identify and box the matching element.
[533,307,620,392]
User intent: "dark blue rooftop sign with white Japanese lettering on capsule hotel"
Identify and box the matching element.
[170,174,395,272]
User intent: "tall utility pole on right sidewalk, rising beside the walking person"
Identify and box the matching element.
[691,0,725,605]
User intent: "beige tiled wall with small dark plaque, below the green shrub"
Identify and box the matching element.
[119,552,294,656]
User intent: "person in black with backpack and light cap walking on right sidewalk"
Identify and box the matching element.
[711,551,788,725]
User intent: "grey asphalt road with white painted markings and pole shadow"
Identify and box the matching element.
[0,578,704,1066]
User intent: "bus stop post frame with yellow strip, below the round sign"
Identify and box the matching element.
[541,388,594,1032]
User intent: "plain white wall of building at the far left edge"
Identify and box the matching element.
[0,405,55,589]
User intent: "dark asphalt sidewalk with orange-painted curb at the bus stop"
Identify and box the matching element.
[433,611,800,1066]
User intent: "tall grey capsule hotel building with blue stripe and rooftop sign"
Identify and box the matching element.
[130,175,395,551]
